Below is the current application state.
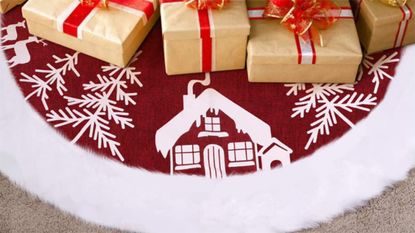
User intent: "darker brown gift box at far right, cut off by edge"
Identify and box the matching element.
[356,0,415,54]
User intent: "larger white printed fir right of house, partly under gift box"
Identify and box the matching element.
[285,84,377,150]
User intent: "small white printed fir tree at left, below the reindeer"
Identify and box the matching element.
[19,52,80,110]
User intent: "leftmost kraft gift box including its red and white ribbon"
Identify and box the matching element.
[23,0,159,67]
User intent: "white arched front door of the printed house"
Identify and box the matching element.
[203,145,226,179]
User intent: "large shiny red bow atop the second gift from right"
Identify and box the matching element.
[264,0,341,46]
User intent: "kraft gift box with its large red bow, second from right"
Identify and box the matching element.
[247,0,362,83]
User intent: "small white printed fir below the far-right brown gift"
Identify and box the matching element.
[358,52,400,94]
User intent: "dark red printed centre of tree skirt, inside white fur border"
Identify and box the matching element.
[2,9,400,178]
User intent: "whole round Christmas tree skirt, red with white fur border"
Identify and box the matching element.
[0,8,415,232]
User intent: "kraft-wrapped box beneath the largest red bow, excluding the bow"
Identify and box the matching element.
[247,1,362,83]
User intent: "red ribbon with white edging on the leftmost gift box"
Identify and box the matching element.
[62,0,158,38]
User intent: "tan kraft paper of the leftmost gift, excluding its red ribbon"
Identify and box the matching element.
[22,0,159,66]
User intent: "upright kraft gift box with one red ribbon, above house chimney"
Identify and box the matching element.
[160,0,250,75]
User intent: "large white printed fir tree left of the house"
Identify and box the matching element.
[46,51,143,161]
